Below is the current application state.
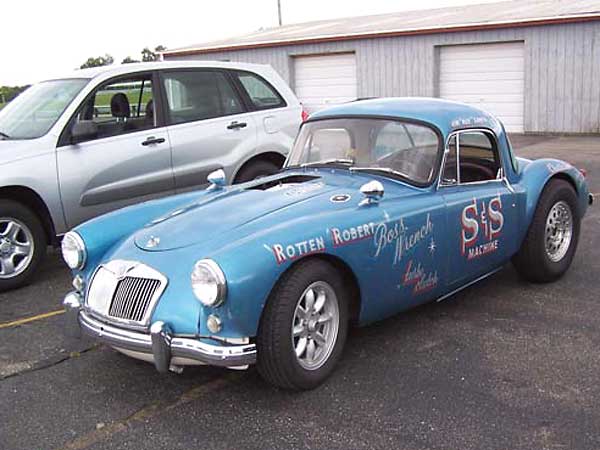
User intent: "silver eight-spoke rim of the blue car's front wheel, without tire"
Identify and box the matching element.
[292,281,340,370]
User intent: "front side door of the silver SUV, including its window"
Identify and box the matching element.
[57,72,175,227]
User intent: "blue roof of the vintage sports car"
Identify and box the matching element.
[310,97,502,136]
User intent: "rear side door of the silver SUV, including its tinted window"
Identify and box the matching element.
[160,68,257,192]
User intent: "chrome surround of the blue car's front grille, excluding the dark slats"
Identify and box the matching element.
[83,259,169,331]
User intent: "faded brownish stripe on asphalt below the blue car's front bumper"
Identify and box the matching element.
[57,372,242,450]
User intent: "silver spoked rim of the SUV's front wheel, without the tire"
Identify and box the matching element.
[0,217,34,279]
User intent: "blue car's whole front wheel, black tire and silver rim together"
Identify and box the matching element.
[257,259,348,390]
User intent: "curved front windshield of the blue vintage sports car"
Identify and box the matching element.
[287,118,441,185]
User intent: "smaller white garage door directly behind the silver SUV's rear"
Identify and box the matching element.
[294,53,357,112]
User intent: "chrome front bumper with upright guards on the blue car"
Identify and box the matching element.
[63,292,256,372]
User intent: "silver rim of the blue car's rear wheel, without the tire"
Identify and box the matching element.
[544,200,573,262]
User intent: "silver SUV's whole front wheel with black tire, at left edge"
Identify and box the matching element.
[0,200,48,291]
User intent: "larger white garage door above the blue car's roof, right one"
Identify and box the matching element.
[439,42,525,132]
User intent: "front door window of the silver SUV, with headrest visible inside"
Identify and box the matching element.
[72,75,156,142]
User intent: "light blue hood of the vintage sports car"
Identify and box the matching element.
[134,170,422,251]
